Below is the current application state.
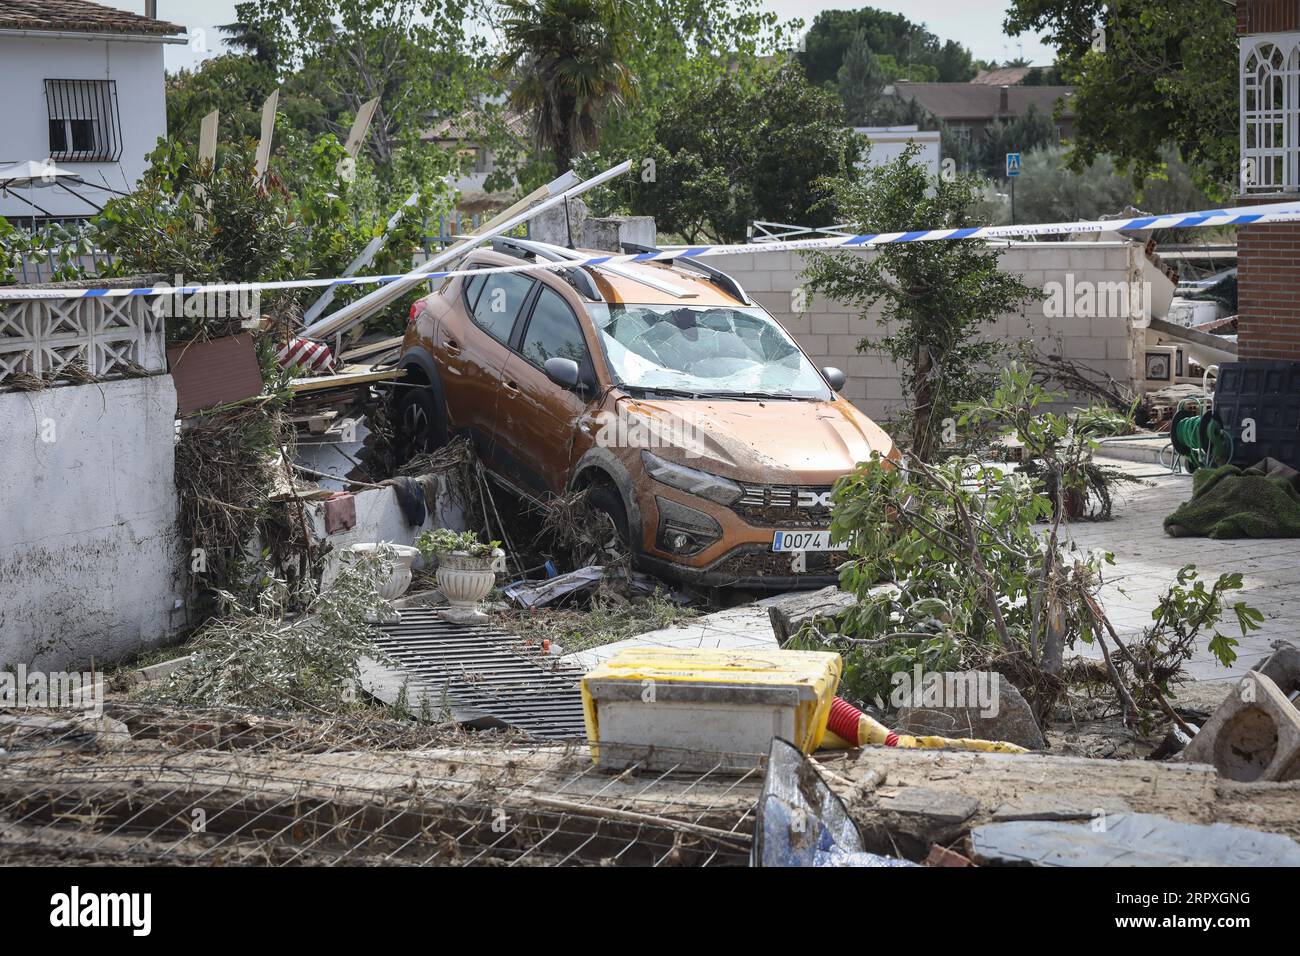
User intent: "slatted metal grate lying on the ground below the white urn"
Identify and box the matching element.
[376,607,586,740]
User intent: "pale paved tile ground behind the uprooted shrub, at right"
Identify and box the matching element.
[1071,462,1300,680]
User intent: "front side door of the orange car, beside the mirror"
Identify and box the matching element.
[497,284,597,494]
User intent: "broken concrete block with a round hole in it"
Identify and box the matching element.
[1179,671,1300,783]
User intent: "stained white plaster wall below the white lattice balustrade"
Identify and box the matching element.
[0,375,183,670]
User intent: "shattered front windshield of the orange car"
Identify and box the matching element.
[588,303,832,401]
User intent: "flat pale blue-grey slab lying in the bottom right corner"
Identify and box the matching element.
[970,813,1300,866]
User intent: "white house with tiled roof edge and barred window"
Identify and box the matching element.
[0,0,187,224]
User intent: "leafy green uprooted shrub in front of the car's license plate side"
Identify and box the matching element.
[796,367,1258,726]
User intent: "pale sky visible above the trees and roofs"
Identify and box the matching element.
[119,0,1053,70]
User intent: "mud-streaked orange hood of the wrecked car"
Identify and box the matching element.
[619,398,896,484]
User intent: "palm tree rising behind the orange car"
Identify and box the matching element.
[498,0,636,174]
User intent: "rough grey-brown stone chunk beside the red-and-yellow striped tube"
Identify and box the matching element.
[894,672,1047,750]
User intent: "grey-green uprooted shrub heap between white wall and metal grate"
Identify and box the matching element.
[138,548,394,713]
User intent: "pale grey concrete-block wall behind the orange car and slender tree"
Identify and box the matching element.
[707,242,1143,419]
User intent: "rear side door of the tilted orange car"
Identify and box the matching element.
[436,272,536,466]
